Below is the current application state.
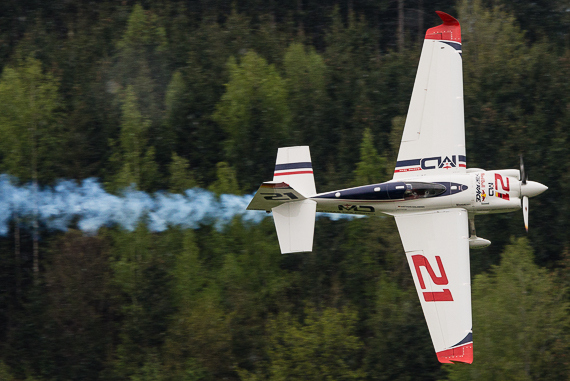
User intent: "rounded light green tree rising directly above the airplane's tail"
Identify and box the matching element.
[213,51,291,188]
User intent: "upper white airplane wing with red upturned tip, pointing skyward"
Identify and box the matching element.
[394,12,466,179]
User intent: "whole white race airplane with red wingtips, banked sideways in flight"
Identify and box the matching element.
[248,12,547,363]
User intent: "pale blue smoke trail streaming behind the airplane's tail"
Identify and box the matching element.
[0,175,351,236]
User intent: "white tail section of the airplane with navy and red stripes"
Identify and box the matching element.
[247,146,317,254]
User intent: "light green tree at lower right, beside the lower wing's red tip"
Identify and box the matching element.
[447,238,570,380]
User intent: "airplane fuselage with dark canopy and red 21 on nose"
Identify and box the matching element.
[310,169,521,215]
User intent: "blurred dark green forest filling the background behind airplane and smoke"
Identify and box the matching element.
[0,0,570,381]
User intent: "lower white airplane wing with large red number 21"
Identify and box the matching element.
[395,209,473,364]
